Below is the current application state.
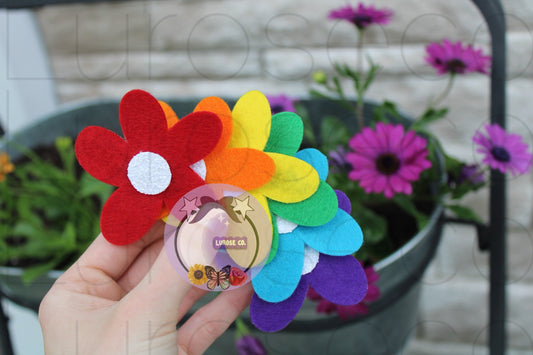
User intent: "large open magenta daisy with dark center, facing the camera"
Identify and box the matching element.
[346,122,431,198]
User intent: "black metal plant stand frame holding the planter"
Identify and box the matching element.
[0,0,507,355]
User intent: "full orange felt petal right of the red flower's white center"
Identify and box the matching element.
[204,148,276,191]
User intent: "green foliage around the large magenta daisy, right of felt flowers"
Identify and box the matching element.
[308,58,485,263]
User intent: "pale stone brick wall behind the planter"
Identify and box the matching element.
[31,0,533,354]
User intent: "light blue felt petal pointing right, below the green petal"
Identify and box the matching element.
[292,208,363,255]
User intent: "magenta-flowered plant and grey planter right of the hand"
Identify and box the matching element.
[223,4,532,354]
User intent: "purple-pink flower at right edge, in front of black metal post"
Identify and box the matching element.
[472,124,532,176]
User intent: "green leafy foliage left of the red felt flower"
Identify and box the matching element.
[0,137,113,282]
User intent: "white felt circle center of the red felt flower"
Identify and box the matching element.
[128,152,172,195]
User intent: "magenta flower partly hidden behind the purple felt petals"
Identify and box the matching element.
[307,266,381,320]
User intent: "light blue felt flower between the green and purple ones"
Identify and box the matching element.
[252,149,363,302]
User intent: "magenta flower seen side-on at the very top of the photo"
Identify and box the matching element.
[328,3,393,29]
